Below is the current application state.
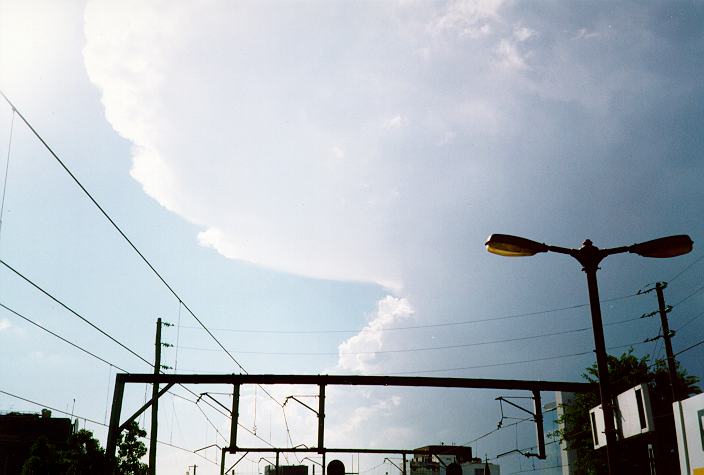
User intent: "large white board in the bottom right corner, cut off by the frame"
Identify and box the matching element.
[672,394,704,475]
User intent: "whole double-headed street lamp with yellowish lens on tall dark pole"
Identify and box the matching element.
[485,234,693,474]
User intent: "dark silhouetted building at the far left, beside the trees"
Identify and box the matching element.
[0,409,72,475]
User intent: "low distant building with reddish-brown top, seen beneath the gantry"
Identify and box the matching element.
[410,445,501,475]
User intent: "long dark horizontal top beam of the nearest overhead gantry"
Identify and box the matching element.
[118,373,598,393]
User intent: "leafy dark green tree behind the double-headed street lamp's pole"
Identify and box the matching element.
[559,349,701,475]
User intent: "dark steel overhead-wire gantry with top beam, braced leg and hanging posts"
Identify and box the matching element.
[106,373,598,475]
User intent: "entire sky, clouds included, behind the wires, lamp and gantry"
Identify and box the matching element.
[0,0,704,473]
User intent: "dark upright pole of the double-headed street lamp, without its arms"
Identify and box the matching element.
[580,262,620,475]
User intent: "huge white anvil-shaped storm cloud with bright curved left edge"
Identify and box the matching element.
[84,0,698,380]
